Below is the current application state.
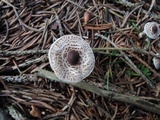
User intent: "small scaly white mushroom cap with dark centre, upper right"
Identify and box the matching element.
[144,22,160,39]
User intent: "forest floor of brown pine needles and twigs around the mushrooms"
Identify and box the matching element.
[0,0,160,120]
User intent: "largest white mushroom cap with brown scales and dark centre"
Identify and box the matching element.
[48,35,95,83]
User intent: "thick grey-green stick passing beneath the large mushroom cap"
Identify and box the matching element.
[36,69,160,115]
